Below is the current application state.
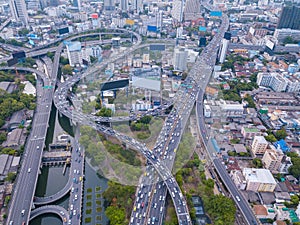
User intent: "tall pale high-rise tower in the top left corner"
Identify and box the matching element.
[10,0,28,27]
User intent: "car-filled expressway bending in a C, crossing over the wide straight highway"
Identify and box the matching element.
[54,35,191,224]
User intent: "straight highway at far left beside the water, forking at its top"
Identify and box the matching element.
[3,41,62,224]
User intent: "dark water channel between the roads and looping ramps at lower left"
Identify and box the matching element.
[30,107,107,225]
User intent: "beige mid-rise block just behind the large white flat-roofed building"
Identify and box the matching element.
[262,146,284,172]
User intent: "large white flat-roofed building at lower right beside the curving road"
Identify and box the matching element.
[243,168,276,192]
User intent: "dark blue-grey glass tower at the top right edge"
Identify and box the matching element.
[277,6,300,30]
